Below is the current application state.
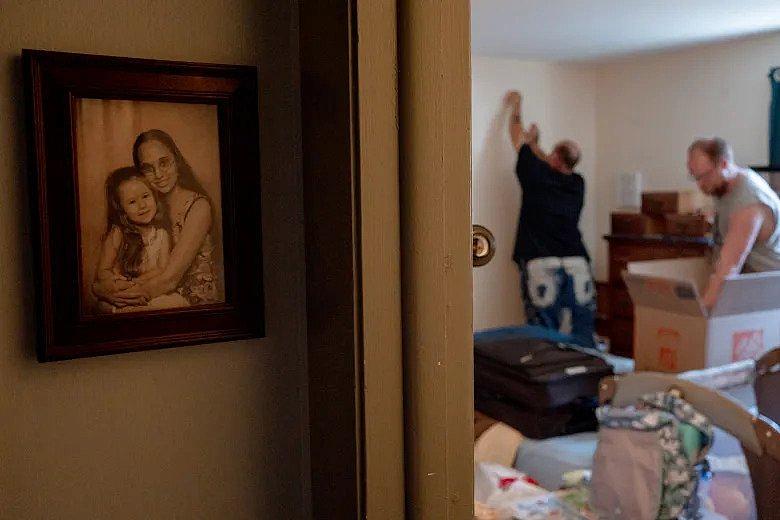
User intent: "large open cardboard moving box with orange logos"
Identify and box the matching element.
[623,258,780,372]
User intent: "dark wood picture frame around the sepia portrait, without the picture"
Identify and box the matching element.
[22,49,265,361]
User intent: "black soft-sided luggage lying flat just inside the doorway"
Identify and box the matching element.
[474,330,613,439]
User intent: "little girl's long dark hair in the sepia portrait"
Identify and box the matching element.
[103,166,171,278]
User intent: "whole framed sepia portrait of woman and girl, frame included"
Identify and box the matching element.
[22,50,265,361]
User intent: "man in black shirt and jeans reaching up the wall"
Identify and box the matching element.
[506,91,596,347]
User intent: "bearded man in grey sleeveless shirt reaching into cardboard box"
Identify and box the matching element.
[688,137,780,309]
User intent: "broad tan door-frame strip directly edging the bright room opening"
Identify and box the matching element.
[398,0,474,520]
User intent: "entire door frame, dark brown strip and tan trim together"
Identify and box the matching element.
[299,0,473,520]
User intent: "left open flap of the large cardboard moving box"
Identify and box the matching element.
[623,271,707,316]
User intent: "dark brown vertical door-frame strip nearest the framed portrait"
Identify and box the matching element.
[299,0,366,519]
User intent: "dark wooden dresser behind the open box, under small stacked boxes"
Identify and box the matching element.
[596,235,712,357]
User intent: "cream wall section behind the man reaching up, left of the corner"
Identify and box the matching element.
[471,56,596,330]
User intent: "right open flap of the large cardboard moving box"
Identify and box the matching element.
[710,271,780,316]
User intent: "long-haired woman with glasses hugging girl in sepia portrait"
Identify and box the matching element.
[93,130,219,308]
